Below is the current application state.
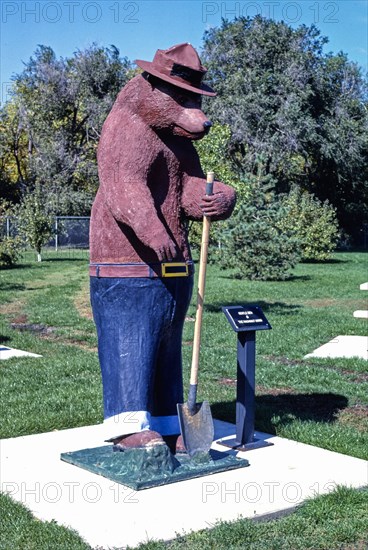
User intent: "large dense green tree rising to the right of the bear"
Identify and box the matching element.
[202,17,368,244]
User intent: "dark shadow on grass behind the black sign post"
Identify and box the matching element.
[211,388,348,434]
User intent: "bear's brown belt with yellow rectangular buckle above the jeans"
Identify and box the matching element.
[89,262,194,278]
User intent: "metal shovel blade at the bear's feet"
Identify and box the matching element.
[177,401,214,457]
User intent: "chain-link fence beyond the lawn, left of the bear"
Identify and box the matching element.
[0,216,90,250]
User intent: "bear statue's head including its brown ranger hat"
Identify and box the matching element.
[128,43,216,140]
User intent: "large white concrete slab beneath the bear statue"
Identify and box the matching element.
[0,421,368,548]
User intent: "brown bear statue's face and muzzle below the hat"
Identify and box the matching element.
[135,76,212,140]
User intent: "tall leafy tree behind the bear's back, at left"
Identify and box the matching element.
[0,45,131,215]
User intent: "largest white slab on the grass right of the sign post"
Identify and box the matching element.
[304,335,368,360]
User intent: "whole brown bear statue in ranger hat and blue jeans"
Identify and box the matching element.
[90,43,235,450]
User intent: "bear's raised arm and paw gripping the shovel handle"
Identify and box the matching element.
[181,147,236,221]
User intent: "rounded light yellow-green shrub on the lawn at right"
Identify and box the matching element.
[280,186,339,261]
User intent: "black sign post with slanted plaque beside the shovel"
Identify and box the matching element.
[218,305,273,451]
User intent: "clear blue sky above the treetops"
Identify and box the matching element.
[0,0,368,104]
